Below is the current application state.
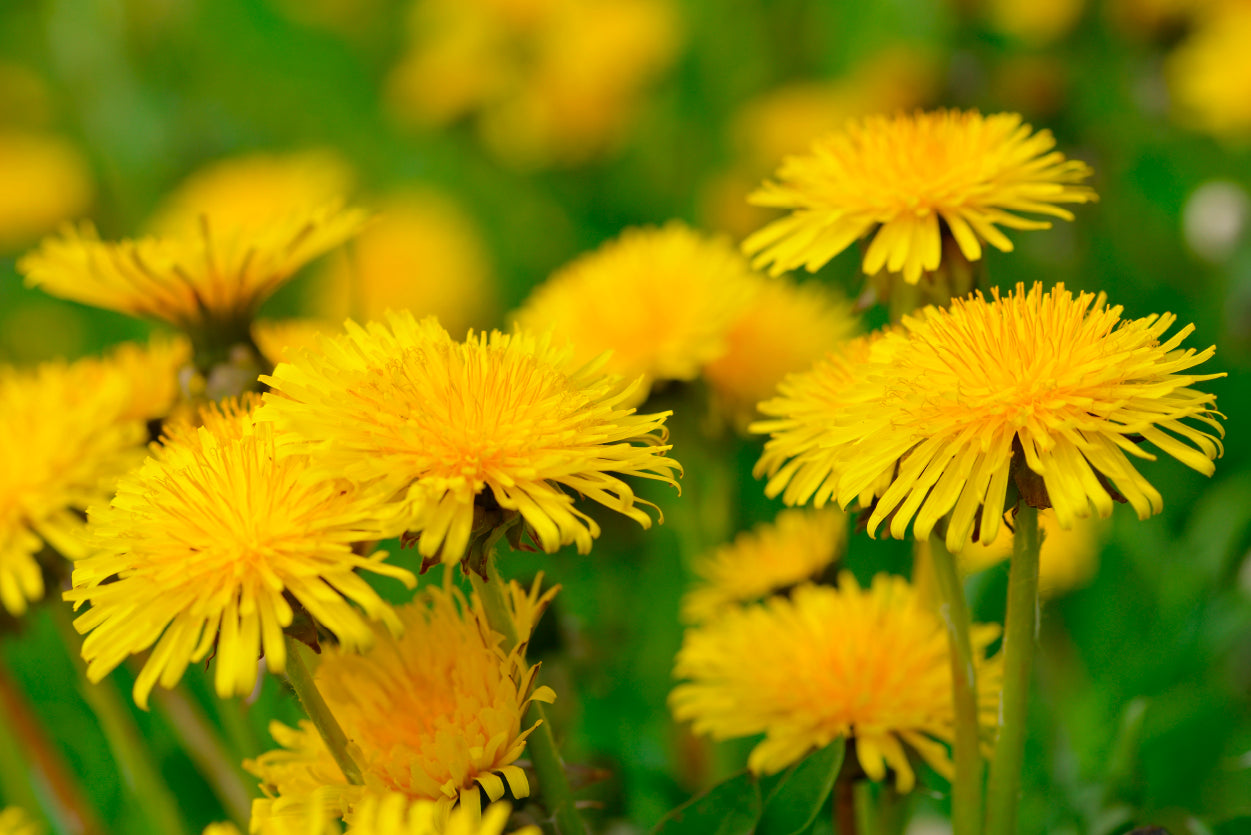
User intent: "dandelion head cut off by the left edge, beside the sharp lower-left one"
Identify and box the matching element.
[0,359,151,615]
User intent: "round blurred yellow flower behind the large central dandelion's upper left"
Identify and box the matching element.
[313,190,494,334]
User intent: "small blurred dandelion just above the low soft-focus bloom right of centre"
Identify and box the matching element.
[682,508,847,623]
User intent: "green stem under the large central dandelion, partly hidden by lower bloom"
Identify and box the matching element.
[469,553,587,835]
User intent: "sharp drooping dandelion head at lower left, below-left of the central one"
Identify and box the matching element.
[65,395,414,706]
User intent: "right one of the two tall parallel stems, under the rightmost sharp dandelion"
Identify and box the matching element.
[986,502,1042,835]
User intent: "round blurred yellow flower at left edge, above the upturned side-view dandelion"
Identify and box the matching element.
[0,129,95,252]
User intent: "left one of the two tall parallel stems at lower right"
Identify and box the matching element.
[929,535,982,835]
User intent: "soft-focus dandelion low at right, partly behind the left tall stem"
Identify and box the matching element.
[669,571,1002,791]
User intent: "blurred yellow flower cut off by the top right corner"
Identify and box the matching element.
[1165,3,1251,136]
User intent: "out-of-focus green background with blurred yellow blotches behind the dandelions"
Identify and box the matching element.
[0,0,1251,834]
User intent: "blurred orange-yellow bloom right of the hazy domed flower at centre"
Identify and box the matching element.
[703,274,859,427]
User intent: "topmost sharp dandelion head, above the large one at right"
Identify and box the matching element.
[743,110,1096,284]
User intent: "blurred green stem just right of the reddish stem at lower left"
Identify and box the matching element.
[46,603,188,835]
